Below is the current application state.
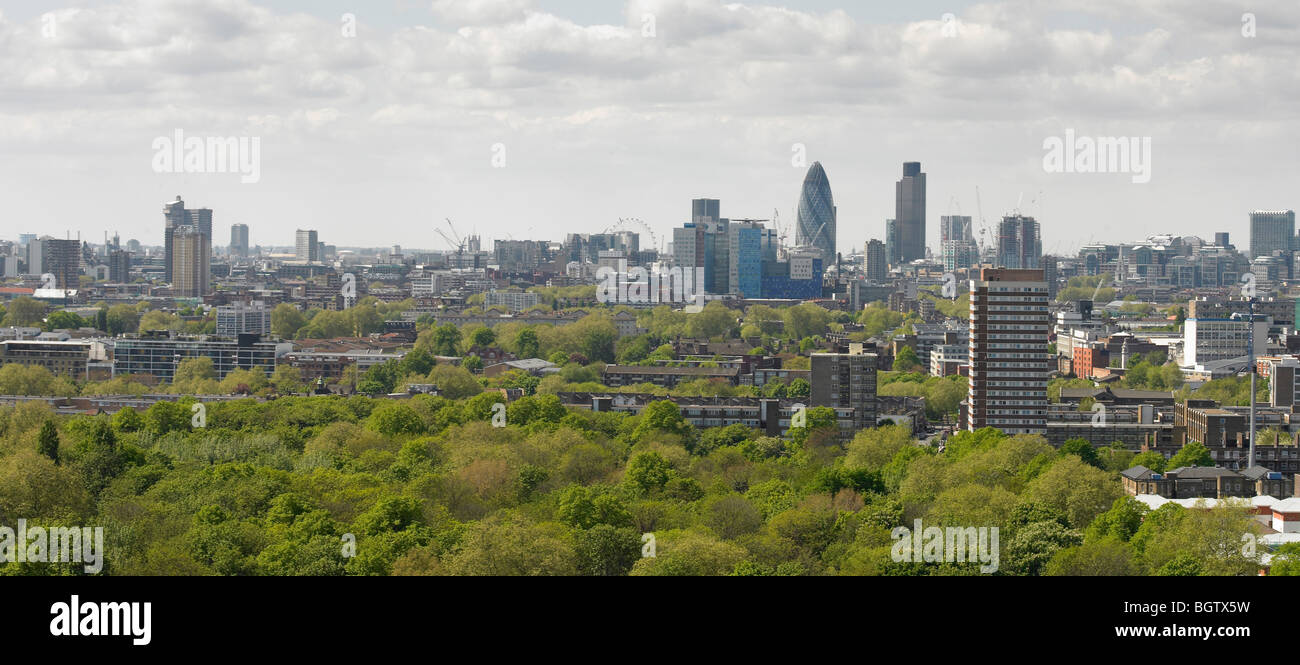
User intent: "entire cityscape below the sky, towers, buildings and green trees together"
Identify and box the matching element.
[0,162,1300,575]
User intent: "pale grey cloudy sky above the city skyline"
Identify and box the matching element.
[0,0,1300,253]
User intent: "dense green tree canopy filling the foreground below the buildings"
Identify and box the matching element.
[0,392,1288,575]
